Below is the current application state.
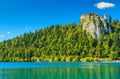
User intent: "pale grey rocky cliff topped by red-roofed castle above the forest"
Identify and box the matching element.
[80,13,112,39]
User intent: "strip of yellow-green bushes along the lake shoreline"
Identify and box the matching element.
[0,56,120,62]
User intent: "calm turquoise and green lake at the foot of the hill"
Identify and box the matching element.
[0,62,120,79]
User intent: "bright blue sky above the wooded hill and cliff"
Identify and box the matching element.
[0,0,120,42]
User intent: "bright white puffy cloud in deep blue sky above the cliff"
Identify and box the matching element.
[94,2,115,9]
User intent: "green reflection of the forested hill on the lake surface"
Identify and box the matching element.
[0,63,120,79]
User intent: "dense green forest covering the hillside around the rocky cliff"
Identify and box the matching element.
[0,20,120,62]
